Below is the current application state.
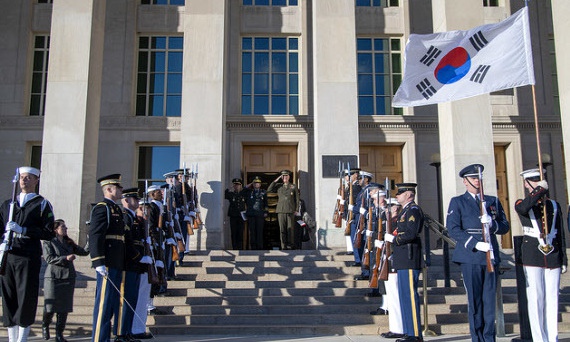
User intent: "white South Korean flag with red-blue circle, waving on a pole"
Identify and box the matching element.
[393,7,535,107]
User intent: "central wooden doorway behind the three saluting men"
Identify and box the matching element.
[242,145,298,249]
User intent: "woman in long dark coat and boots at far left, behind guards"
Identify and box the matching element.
[42,220,89,342]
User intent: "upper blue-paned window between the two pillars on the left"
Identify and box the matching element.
[136,36,184,116]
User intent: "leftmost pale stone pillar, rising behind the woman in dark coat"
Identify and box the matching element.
[40,0,106,243]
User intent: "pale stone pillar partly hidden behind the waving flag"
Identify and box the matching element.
[432,0,497,216]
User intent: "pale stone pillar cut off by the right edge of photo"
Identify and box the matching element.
[551,0,570,202]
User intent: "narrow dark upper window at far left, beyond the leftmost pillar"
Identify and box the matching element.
[29,36,49,116]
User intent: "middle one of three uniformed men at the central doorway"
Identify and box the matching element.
[245,176,268,250]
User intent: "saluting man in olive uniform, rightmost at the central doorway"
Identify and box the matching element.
[267,170,299,250]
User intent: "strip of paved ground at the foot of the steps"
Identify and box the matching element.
[22,333,570,342]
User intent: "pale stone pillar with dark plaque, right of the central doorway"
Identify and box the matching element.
[312,0,359,247]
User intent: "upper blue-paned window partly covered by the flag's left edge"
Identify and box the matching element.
[356,38,403,115]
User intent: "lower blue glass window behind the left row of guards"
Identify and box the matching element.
[137,146,180,189]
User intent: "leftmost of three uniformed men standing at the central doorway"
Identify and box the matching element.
[225,178,247,250]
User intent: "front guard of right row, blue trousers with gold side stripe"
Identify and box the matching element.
[384,183,424,341]
